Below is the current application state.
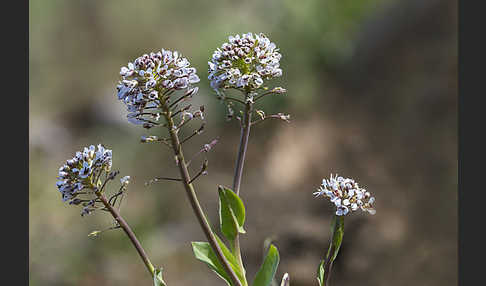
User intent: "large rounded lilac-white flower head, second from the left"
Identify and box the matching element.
[117,49,199,128]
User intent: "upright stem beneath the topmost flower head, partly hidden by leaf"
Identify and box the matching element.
[233,101,253,268]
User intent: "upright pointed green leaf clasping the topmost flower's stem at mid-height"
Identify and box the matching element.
[218,186,246,241]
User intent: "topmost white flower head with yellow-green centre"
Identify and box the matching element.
[208,33,282,89]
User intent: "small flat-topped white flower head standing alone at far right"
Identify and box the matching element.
[313,174,376,216]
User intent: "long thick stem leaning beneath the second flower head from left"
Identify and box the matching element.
[162,103,242,286]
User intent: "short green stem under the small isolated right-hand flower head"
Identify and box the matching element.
[318,215,344,286]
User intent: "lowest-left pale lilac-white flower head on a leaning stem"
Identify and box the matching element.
[56,144,112,208]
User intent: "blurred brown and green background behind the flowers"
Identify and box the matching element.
[29,0,458,286]
